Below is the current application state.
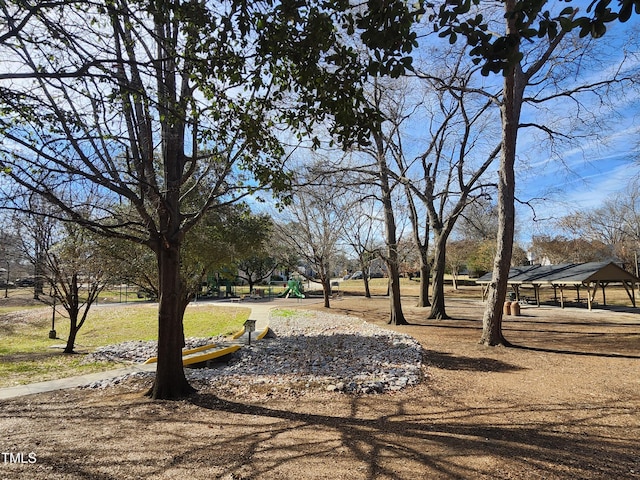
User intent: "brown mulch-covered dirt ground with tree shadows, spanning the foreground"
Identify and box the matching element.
[0,298,640,480]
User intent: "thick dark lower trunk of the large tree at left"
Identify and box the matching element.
[149,238,195,400]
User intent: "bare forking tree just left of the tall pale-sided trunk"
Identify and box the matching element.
[398,49,501,319]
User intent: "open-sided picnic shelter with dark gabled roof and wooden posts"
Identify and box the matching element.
[476,261,640,310]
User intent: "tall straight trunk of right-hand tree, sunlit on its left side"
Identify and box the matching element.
[480,0,524,346]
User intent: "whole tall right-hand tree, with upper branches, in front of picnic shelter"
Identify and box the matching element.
[437,0,634,345]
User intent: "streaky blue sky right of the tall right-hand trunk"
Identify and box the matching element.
[516,16,640,244]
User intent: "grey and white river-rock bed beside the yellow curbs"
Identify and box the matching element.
[88,311,423,395]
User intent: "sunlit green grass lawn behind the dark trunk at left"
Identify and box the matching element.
[0,303,250,387]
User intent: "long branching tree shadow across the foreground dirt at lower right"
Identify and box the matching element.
[191,394,636,480]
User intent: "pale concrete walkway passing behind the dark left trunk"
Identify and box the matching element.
[0,299,322,400]
